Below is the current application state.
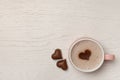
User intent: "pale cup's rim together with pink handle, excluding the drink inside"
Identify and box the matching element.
[68,37,115,72]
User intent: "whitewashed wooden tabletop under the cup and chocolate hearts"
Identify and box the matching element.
[0,0,120,80]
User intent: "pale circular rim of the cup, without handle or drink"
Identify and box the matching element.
[68,37,104,72]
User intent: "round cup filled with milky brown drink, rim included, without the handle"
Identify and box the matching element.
[69,37,114,72]
